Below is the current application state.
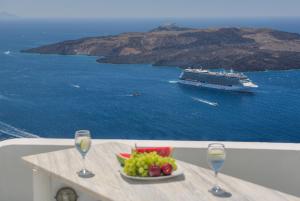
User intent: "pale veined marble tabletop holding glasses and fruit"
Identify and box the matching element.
[23,142,300,201]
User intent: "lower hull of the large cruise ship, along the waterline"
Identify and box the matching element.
[178,80,256,92]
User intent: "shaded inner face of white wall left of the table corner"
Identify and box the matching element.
[0,145,71,201]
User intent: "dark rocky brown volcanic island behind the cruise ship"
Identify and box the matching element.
[22,24,300,71]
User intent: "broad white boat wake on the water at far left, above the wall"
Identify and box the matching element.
[0,121,39,138]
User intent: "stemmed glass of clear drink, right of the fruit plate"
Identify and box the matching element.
[207,143,226,196]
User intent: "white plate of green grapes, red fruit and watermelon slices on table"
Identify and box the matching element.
[117,147,183,180]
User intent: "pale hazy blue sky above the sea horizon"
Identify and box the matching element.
[0,0,300,18]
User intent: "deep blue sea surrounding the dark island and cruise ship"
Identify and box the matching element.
[0,18,300,142]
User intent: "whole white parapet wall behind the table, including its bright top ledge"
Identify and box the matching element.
[0,139,300,201]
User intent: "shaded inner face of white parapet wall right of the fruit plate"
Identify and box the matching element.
[175,148,300,197]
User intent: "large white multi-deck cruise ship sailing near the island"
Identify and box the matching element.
[179,69,258,91]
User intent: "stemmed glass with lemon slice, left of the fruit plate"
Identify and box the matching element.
[75,130,94,178]
